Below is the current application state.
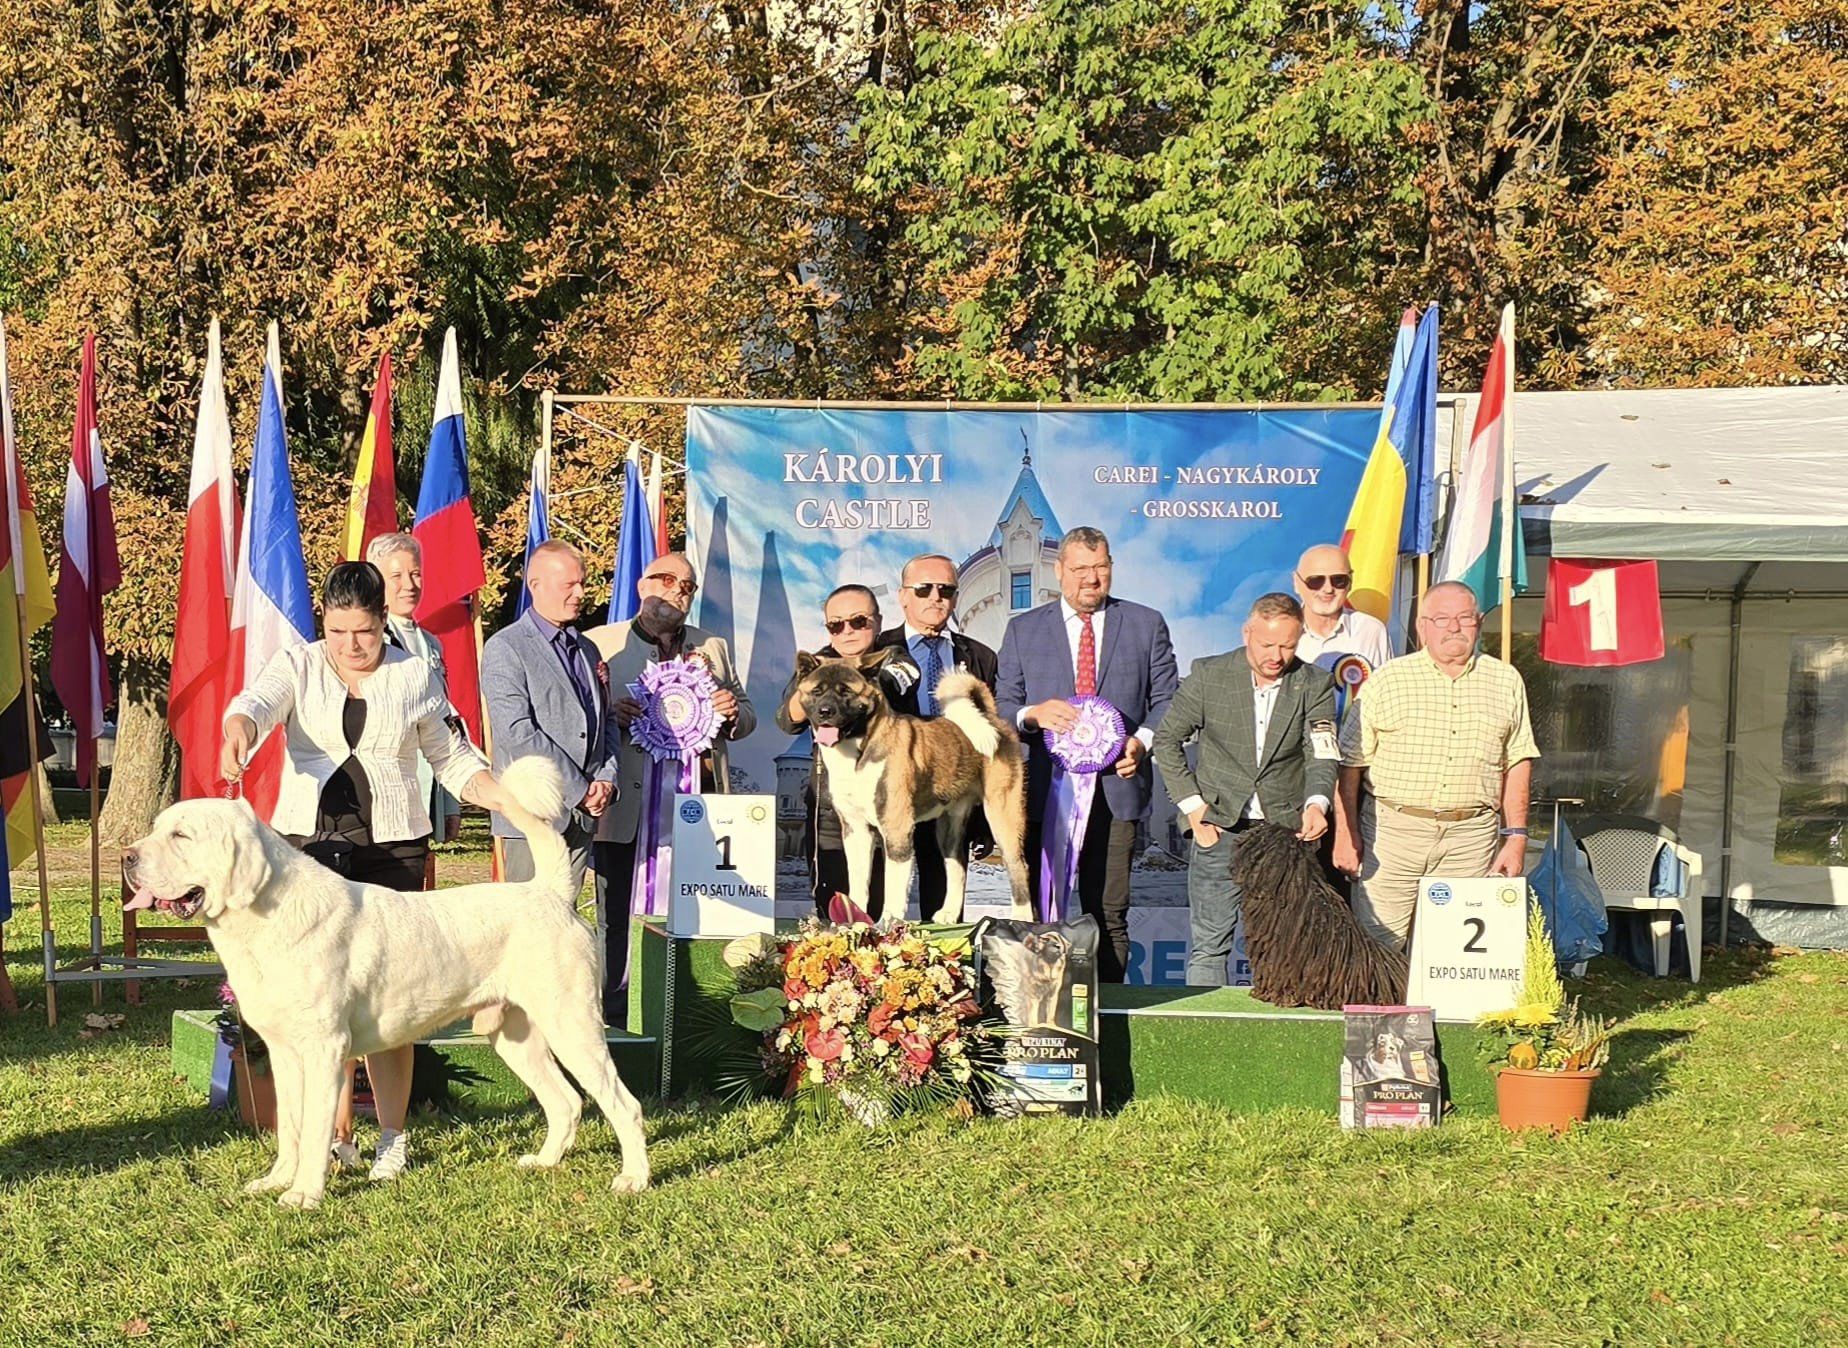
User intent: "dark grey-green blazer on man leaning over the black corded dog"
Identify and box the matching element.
[1155,647,1338,828]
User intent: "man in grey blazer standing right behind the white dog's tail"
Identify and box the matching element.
[480,542,621,893]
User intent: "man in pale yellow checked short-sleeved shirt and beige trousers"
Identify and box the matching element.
[1334,581,1539,947]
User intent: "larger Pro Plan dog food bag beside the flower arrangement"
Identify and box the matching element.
[970,917,1103,1117]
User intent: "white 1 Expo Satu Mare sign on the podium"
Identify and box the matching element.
[667,795,776,936]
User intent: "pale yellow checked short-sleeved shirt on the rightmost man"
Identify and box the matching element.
[1342,651,1539,810]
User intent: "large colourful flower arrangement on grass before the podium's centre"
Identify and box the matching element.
[726,917,1000,1126]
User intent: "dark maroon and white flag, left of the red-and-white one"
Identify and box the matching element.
[52,333,122,786]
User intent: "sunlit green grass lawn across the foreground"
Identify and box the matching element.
[0,875,1848,1346]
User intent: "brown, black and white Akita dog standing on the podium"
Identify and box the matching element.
[796,649,1033,923]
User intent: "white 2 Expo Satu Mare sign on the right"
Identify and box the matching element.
[1404,875,1526,1021]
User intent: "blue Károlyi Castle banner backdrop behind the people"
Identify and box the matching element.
[687,407,1379,935]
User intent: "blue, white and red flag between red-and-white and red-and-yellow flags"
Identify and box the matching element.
[227,324,314,821]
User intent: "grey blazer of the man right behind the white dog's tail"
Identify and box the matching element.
[480,614,621,838]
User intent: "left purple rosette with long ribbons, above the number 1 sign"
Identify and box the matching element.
[628,656,719,917]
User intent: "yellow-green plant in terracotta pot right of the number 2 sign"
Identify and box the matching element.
[1477,906,1611,1134]
